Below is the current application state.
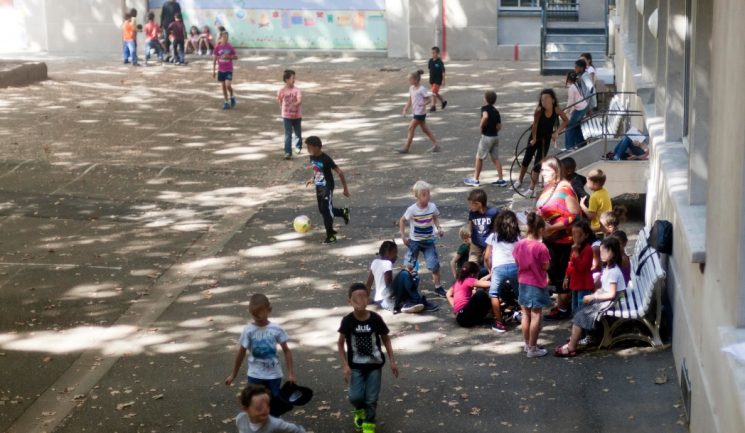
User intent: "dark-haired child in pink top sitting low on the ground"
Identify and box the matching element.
[447,262,491,328]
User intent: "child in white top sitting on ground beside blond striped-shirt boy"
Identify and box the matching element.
[365,241,440,314]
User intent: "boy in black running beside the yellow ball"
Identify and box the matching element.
[305,135,349,244]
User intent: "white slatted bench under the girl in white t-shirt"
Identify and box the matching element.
[600,229,666,348]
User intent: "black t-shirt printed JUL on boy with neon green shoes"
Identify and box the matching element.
[339,311,389,371]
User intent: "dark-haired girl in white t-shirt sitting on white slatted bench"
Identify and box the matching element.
[554,237,626,358]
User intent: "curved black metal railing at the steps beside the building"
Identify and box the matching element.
[508,92,644,197]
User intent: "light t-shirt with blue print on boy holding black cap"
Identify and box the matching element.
[238,323,288,379]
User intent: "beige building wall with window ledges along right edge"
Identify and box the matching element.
[614,0,745,433]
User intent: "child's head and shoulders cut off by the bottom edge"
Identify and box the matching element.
[235,385,305,433]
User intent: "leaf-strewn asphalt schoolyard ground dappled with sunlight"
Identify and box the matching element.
[0,54,685,433]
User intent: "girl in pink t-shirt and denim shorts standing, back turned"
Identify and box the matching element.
[512,212,551,358]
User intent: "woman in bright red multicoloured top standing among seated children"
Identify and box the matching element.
[536,156,580,320]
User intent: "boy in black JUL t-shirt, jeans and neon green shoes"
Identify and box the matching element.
[337,283,398,433]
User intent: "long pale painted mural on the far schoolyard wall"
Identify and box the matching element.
[148,0,388,50]
